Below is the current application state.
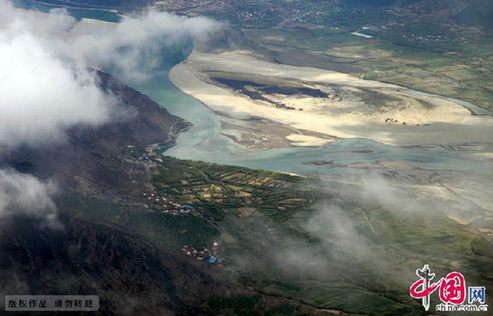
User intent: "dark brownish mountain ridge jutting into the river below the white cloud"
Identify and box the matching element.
[0,73,189,193]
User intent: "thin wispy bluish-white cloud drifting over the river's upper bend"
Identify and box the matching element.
[67,11,221,80]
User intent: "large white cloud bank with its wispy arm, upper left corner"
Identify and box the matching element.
[0,0,219,149]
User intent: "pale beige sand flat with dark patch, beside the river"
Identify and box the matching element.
[170,51,493,146]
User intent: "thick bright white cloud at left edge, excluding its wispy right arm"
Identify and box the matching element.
[0,32,112,147]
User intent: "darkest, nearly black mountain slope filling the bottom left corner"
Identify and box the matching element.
[0,215,214,315]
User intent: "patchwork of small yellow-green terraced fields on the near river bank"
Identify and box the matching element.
[152,157,317,221]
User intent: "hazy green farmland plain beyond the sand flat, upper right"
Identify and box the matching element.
[235,7,493,110]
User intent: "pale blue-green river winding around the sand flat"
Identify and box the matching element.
[16,1,491,175]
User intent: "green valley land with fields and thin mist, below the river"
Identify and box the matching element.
[61,154,493,315]
